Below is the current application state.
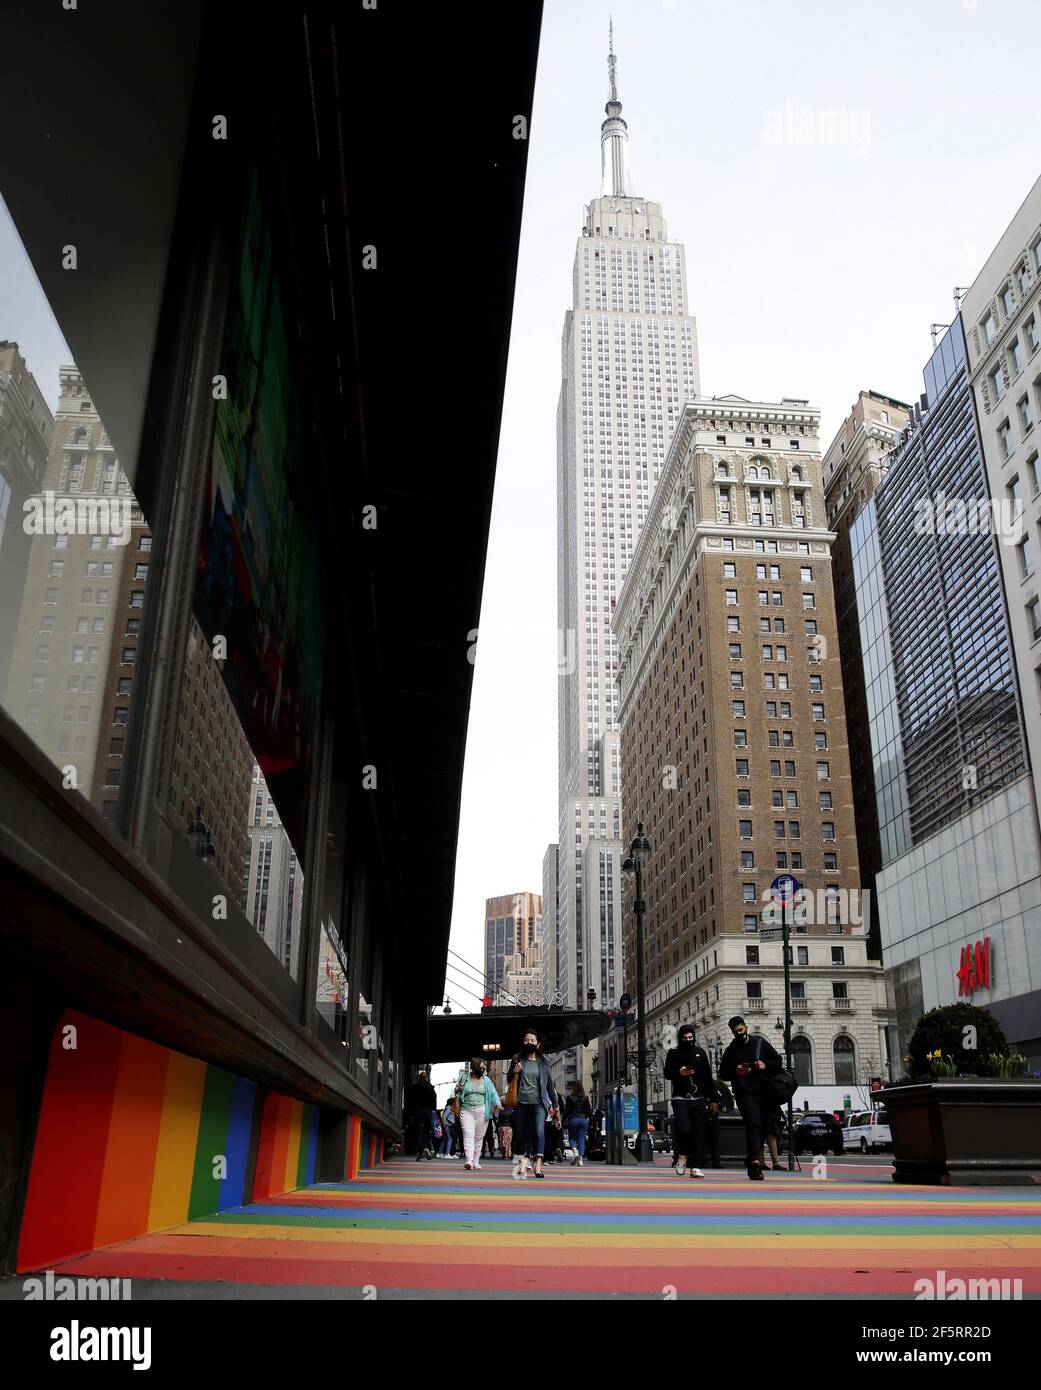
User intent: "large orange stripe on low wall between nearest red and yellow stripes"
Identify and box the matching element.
[95,1033,170,1247]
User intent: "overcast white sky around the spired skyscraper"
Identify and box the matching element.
[436,0,1041,1034]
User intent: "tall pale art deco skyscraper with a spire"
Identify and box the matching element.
[552,27,699,1045]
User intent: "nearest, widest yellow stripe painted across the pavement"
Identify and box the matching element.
[174,1222,1041,1258]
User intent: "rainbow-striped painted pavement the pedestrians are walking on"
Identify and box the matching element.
[32,1159,1041,1298]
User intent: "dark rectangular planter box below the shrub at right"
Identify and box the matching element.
[878,1076,1041,1187]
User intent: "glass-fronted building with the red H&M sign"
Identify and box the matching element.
[851,320,1041,1056]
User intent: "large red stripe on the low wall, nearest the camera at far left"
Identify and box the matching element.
[17,1012,121,1270]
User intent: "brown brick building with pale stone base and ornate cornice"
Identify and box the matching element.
[614,396,885,1084]
